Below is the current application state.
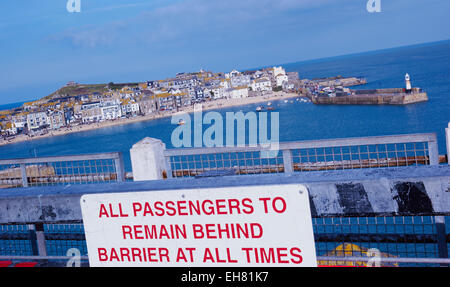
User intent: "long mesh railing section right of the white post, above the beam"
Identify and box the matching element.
[164,134,439,178]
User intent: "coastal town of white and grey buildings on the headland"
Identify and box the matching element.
[0,67,365,144]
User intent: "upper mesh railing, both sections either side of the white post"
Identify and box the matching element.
[0,134,440,188]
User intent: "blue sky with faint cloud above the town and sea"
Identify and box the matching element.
[0,0,450,104]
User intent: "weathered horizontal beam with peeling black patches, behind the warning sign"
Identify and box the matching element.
[0,165,450,223]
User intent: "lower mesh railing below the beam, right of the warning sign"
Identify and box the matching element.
[313,216,450,267]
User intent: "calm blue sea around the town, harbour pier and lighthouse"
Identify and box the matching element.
[0,41,450,170]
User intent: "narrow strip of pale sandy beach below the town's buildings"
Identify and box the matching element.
[0,92,299,146]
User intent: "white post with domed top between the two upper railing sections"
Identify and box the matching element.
[130,137,169,181]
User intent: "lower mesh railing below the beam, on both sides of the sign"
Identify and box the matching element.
[0,216,450,267]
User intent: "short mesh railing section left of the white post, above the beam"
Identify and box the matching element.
[0,152,125,188]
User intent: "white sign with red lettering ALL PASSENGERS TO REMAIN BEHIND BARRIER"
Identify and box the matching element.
[81,184,317,267]
